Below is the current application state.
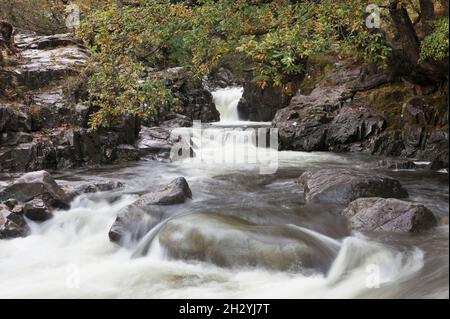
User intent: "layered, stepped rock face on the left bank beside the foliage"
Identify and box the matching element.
[0,34,140,172]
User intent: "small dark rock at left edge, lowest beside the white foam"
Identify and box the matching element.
[0,205,30,239]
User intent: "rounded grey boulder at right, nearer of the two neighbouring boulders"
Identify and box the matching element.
[342,198,437,233]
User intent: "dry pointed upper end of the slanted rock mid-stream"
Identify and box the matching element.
[134,177,192,207]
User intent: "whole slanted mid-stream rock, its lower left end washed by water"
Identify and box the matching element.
[109,177,192,246]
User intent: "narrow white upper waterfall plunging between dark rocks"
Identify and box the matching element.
[212,87,244,122]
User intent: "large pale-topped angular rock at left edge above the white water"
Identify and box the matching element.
[0,171,70,209]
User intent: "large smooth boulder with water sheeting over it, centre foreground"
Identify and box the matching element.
[155,214,336,273]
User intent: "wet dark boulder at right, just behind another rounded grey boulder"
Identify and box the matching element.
[299,169,408,204]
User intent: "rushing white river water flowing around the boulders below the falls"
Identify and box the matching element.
[0,89,449,298]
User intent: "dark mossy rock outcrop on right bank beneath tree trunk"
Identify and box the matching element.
[273,59,448,169]
